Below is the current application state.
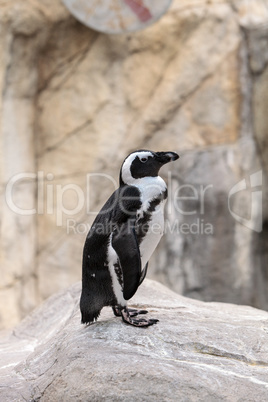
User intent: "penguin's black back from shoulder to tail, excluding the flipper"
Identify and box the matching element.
[80,185,141,323]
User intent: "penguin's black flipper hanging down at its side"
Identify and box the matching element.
[112,219,141,300]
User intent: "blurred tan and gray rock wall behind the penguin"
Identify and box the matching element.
[0,0,268,328]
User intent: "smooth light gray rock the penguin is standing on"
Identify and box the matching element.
[0,280,268,402]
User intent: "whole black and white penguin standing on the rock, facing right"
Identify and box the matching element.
[80,150,179,327]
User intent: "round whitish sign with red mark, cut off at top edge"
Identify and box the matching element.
[62,0,172,34]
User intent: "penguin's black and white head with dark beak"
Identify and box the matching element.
[120,150,179,185]
